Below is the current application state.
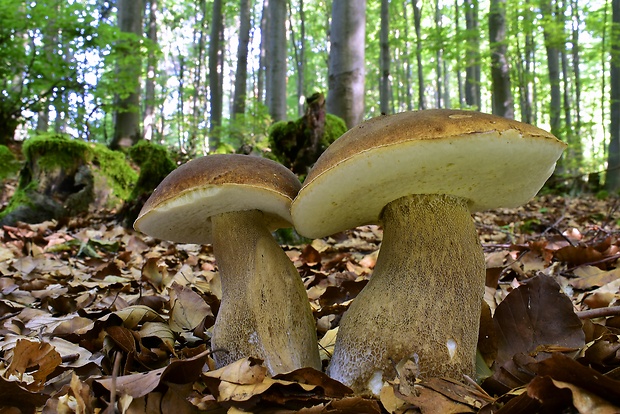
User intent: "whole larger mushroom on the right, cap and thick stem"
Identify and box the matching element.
[291,110,565,395]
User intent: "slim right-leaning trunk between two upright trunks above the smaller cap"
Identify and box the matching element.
[232,0,251,118]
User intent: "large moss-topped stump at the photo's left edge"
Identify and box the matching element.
[0,134,137,224]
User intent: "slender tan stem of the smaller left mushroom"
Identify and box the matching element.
[211,210,321,375]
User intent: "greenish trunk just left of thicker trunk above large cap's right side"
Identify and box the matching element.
[464,0,482,110]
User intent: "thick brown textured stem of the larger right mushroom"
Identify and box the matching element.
[328,195,485,394]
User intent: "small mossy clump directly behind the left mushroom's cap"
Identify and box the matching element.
[129,141,176,200]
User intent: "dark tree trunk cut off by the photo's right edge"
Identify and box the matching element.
[605,0,620,192]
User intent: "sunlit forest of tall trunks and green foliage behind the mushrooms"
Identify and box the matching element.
[0,0,620,191]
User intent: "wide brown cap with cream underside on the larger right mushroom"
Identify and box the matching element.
[291,109,566,237]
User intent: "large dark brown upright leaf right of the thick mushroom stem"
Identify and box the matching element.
[493,275,585,366]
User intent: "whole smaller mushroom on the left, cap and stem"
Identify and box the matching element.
[134,155,321,375]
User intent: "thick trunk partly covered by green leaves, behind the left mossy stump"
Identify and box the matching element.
[110,0,144,149]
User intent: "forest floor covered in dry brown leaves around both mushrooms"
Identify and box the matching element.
[0,192,620,414]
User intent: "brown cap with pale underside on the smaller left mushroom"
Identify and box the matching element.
[134,154,301,244]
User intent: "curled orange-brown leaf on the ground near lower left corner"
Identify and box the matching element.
[6,339,62,391]
